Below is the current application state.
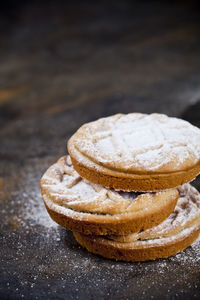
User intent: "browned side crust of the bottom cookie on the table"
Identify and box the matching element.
[73,226,200,261]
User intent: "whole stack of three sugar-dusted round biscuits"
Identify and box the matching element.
[41,113,200,261]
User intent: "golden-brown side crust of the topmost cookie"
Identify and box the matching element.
[69,150,200,192]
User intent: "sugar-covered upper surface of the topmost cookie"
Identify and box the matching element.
[72,113,200,172]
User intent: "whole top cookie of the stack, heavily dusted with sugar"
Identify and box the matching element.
[68,113,200,191]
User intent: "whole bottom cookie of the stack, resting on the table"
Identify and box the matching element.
[73,184,200,261]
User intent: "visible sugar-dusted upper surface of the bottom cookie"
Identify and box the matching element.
[110,184,200,246]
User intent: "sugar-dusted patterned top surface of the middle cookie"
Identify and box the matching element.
[41,156,164,215]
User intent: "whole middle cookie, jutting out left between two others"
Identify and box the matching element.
[41,156,179,235]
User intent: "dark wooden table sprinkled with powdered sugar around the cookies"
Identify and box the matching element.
[0,1,200,300]
